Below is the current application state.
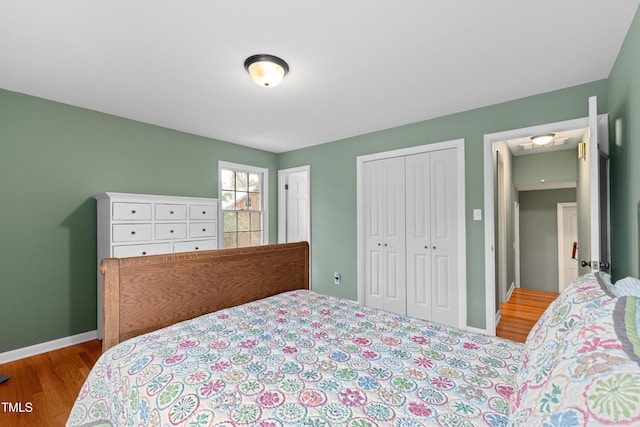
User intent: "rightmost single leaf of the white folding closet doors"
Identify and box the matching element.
[429,150,459,325]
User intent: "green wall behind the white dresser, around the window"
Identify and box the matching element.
[0,90,277,353]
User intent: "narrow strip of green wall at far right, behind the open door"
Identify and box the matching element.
[608,9,640,279]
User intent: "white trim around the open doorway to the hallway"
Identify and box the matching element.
[484,117,589,335]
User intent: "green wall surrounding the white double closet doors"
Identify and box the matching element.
[278,80,607,328]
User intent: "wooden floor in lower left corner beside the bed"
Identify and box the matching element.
[0,340,102,427]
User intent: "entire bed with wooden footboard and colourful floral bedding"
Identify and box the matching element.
[67,243,640,427]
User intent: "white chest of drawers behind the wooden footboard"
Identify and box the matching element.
[94,193,219,338]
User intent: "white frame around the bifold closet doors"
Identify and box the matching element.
[356,139,467,328]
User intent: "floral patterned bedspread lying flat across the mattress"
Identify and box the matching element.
[68,291,524,427]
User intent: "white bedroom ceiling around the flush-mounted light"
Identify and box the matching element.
[0,0,640,152]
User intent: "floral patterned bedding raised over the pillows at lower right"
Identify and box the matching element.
[509,273,640,427]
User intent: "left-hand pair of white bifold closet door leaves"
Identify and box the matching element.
[363,157,406,315]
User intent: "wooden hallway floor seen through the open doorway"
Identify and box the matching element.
[496,288,559,342]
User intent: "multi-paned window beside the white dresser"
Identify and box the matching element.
[218,162,269,248]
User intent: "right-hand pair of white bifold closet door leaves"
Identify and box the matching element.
[405,149,458,325]
